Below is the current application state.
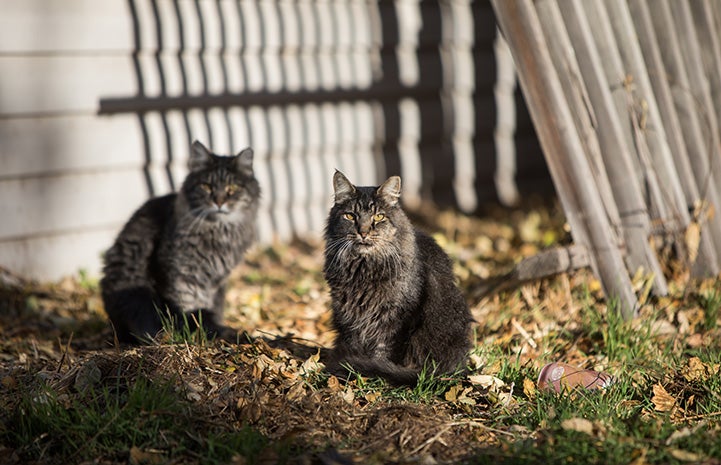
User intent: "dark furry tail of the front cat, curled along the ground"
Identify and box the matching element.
[326,356,420,386]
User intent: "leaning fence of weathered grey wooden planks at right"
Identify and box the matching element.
[491,0,721,317]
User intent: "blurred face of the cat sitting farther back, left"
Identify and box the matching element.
[181,141,260,221]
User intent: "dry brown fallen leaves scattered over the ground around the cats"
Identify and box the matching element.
[0,201,721,463]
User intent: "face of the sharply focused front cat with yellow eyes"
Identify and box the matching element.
[326,171,405,255]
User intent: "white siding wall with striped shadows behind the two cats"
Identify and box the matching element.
[0,0,536,279]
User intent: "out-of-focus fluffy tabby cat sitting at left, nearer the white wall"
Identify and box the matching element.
[100,141,260,342]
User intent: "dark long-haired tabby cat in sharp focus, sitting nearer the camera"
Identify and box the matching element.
[323,171,473,385]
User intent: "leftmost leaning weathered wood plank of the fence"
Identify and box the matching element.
[492,0,637,318]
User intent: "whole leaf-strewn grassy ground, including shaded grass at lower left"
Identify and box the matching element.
[0,211,721,465]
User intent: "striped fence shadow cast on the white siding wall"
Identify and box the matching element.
[99,0,545,236]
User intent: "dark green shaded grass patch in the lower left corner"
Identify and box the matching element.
[3,370,289,464]
